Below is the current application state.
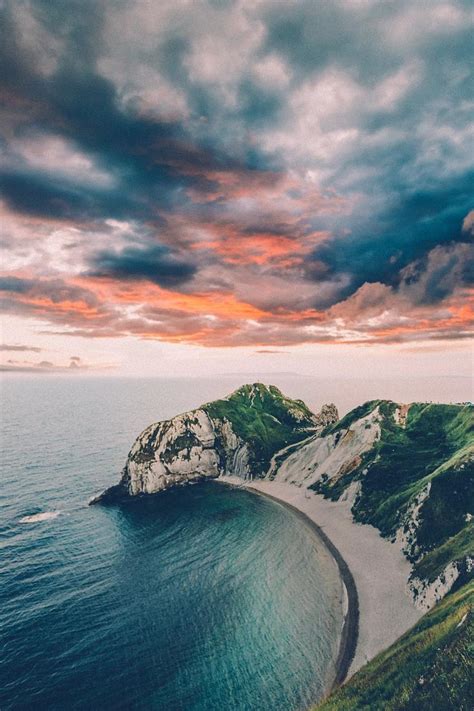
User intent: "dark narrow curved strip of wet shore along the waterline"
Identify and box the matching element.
[215,477,359,693]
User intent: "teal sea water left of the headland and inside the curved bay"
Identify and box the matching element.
[0,377,342,711]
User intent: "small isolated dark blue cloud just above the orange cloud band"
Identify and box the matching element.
[89,245,196,288]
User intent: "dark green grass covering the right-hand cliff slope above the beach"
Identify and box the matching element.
[314,401,474,574]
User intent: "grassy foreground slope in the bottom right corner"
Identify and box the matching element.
[317,582,474,711]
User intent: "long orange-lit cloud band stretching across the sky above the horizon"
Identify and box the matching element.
[0,266,474,348]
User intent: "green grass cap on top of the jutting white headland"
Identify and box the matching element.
[203,383,315,475]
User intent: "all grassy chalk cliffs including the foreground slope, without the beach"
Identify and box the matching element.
[96,383,474,711]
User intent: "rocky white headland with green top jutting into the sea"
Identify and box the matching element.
[98,383,338,501]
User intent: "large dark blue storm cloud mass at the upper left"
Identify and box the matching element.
[0,2,258,228]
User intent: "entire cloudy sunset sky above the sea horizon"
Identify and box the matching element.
[0,0,474,384]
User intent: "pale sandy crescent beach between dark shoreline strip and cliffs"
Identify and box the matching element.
[219,477,421,681]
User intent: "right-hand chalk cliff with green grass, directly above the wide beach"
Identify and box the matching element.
[270,400,474,610]
